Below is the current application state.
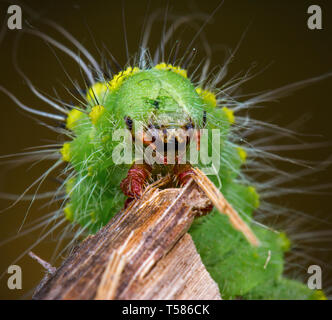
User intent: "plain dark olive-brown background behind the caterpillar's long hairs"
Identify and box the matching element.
[0,0,332,299]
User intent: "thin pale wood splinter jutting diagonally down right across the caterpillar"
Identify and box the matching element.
[192,168,259,246]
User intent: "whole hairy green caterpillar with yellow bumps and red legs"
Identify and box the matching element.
[0,0,327,299]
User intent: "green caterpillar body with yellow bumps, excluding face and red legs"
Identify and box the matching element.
[0,4,325,299]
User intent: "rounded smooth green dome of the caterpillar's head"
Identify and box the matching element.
[115,64,206,155]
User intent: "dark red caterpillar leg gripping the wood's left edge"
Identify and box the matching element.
[120,163,152,201]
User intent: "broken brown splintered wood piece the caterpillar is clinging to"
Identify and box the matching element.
[33,178,220,299]
